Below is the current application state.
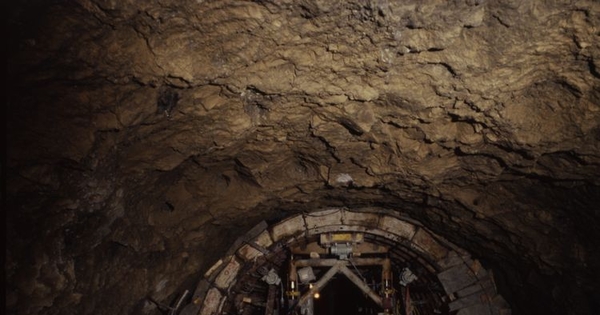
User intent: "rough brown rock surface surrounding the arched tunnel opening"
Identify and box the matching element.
[5,0,600,314]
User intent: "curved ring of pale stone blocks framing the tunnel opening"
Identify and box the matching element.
[181,208,511,315]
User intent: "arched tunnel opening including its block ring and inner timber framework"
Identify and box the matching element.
[188,209,511,315]
